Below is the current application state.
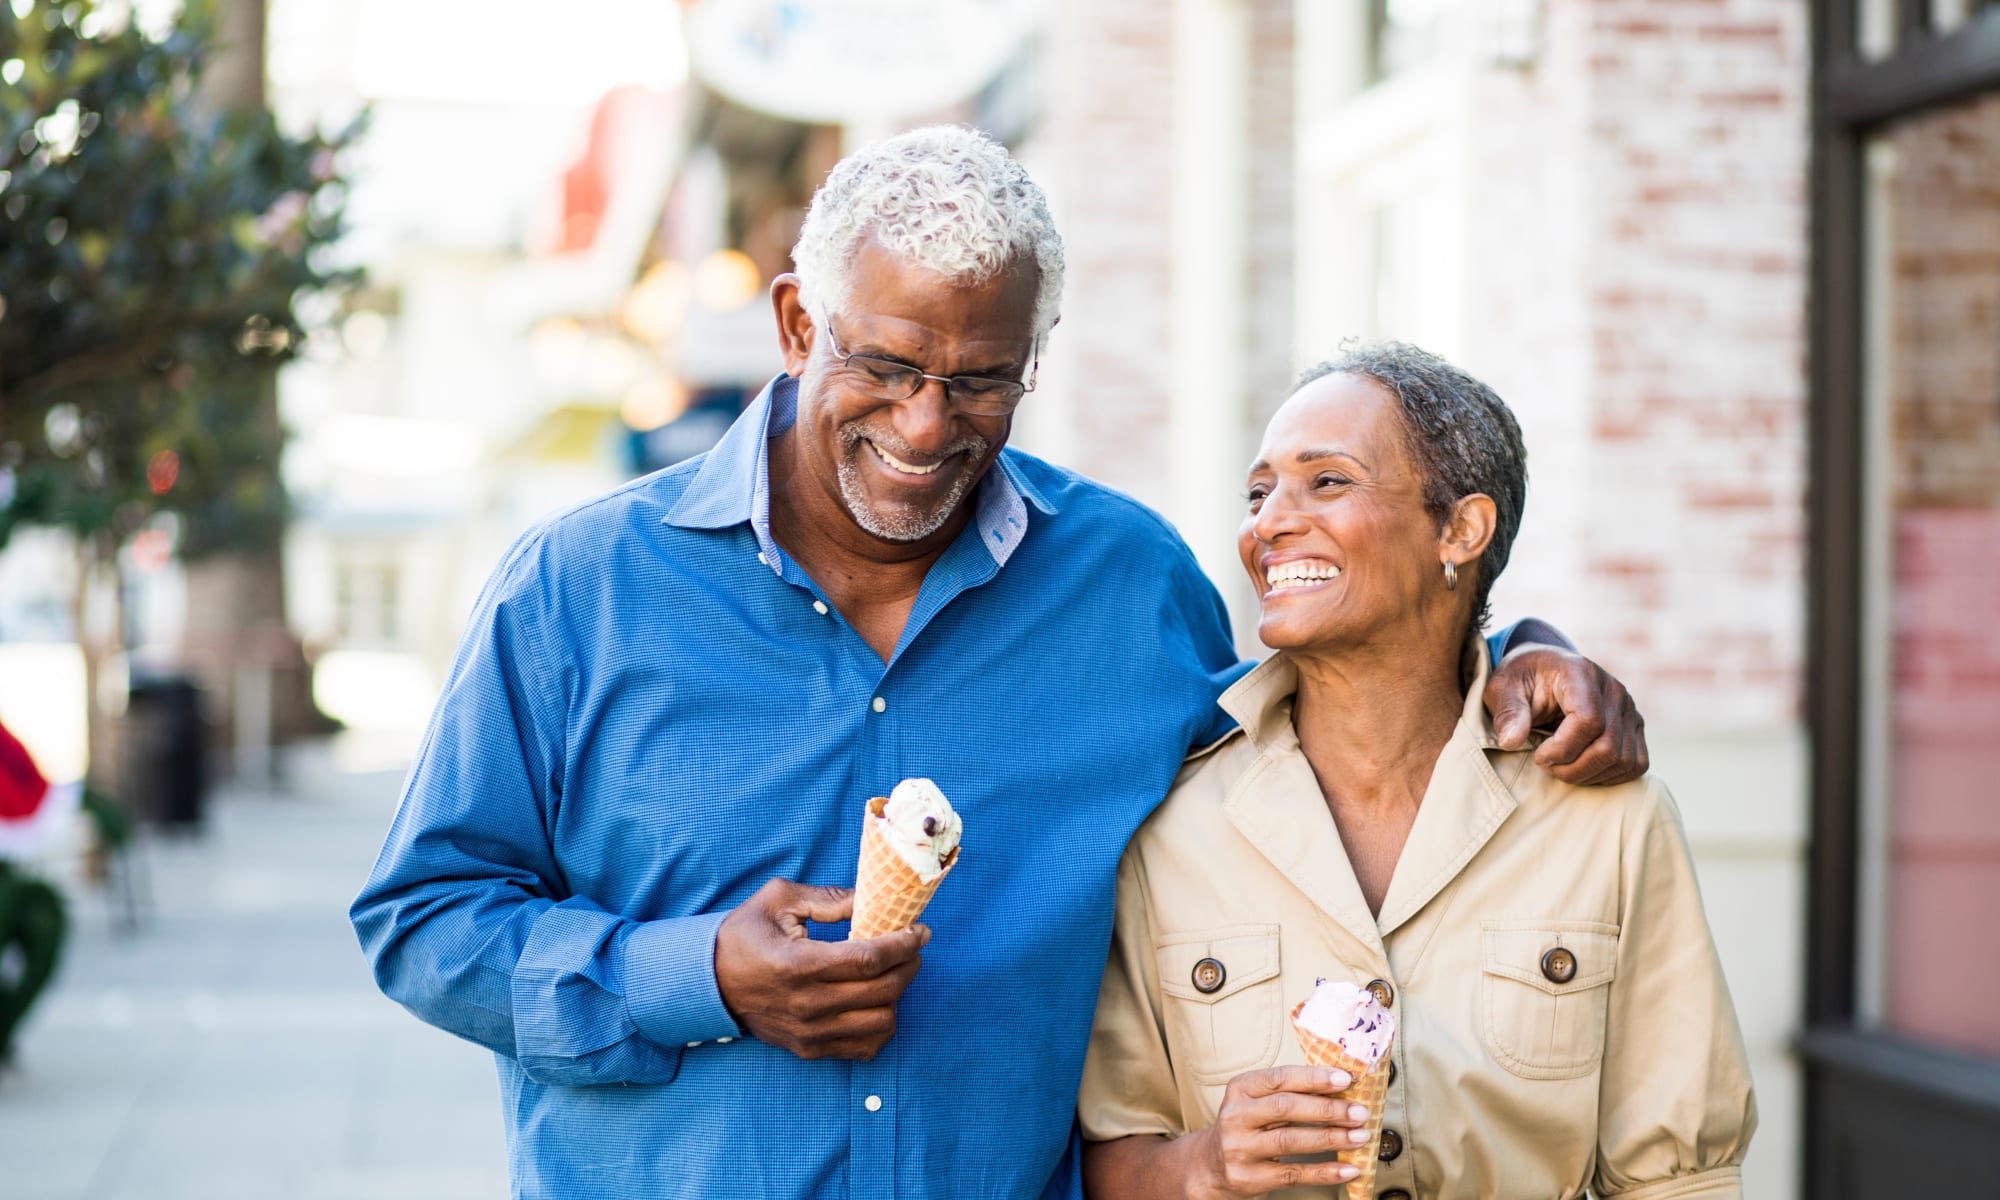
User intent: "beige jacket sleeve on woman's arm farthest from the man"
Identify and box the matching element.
[1592,776,1756,1200]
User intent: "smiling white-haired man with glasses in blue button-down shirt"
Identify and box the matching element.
[352,128,1644,1200]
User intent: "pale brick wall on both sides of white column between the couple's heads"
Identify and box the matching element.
[1020,0,1294,510]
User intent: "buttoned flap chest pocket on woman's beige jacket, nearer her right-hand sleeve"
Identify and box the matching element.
[1480,920,1618,1080]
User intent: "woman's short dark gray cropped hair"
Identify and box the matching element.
[1292,342,1528,630]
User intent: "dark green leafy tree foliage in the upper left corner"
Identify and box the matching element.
[0,0,358,552]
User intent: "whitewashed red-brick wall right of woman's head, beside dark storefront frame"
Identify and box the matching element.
[1468,0,1808,726]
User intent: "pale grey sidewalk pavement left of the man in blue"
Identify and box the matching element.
[0,742,508,1200]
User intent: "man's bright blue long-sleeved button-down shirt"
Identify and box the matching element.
[352,378,1528,1200]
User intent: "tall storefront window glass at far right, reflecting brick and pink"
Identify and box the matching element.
[1858,94,2000,1054]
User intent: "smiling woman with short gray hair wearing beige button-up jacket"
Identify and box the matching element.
[1080,344,1756,1200]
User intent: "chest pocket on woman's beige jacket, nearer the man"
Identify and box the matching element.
[1154,924,1284,1084]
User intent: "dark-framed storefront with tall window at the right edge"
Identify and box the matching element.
[1800,0,2000,1198]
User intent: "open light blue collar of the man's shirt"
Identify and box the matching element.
[662,374,1056,578]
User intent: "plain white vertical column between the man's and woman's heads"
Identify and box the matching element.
[1166,0,1250,618]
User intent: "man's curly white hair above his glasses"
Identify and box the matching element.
[792,126,1062,342]
